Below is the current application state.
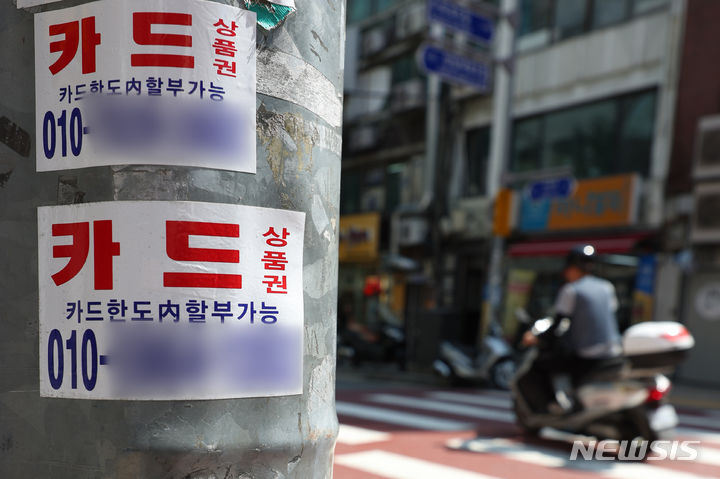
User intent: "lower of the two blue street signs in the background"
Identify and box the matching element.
[419,45,490,91]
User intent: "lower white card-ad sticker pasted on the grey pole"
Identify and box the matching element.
[38,201,305,400]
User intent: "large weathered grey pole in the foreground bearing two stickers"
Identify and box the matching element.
[0,0,345,479]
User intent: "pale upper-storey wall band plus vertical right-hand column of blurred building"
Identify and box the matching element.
[463,0,685,231]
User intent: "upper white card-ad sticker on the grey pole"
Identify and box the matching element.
[35,0,256,173]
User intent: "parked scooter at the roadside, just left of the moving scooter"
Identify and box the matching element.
[433,322,517,390]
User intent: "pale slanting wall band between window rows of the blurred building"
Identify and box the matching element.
[463,10,674,129]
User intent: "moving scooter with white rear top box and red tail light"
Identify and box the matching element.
[512,318,695,441]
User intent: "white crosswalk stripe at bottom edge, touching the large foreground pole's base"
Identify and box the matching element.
[335,450,504,479]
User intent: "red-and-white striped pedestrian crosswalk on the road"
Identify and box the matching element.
[334,390,720,479]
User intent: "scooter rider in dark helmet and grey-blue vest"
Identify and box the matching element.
[525,245,623,413]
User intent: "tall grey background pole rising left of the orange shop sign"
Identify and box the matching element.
[478,0,518,342]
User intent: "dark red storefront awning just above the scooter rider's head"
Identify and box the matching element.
[508,233,649,256]
